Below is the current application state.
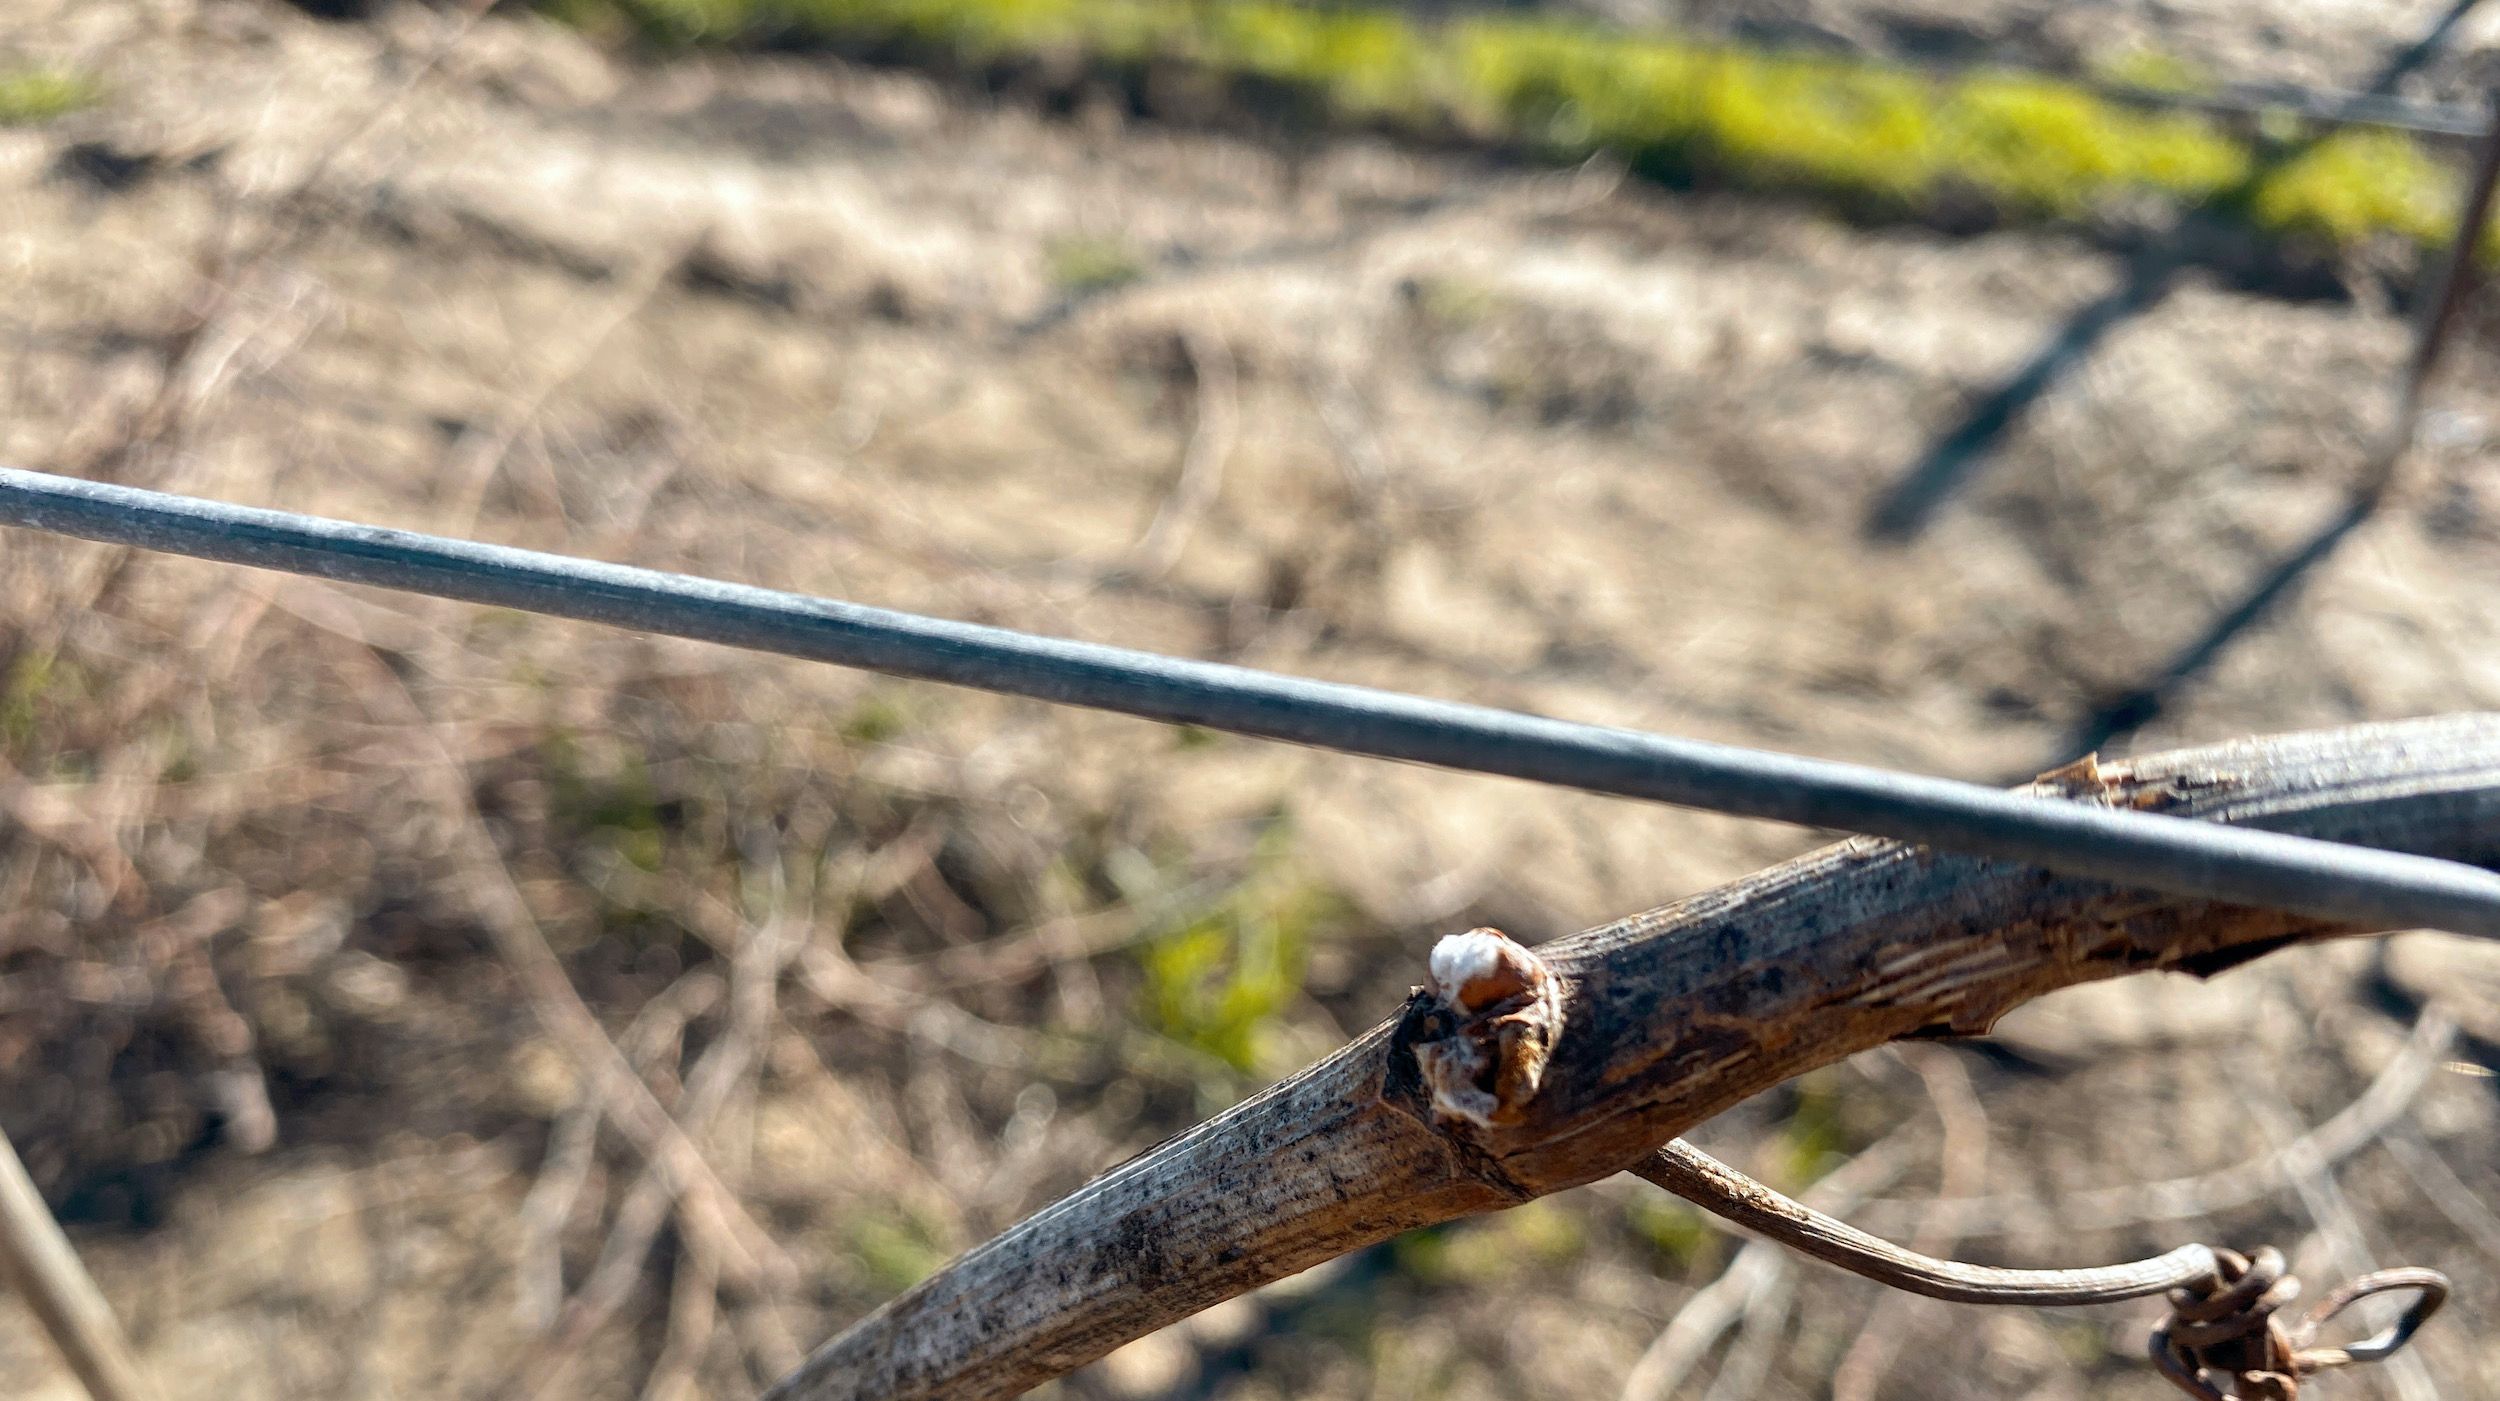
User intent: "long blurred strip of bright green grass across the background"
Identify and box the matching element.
[562,0,2458,248]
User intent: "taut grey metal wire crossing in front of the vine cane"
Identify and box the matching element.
[0,468,2500,938]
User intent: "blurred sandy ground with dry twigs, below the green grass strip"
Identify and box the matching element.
[0,0,2500,1398]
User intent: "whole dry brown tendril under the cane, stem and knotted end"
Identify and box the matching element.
[1630,1138,2448,1401]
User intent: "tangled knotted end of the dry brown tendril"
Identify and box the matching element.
[2153,1246,2448,1401]
